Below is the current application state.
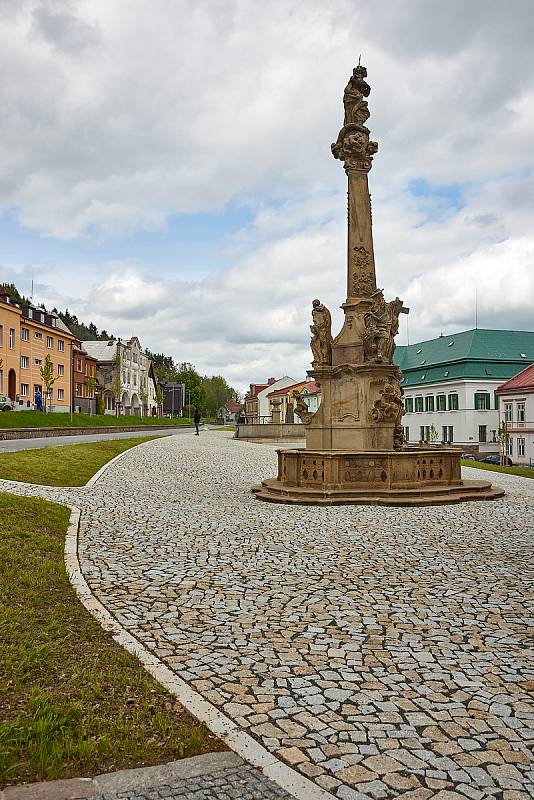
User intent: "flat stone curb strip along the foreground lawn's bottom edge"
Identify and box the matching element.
[0,752,243,800]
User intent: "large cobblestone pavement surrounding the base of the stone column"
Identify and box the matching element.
[3,433,534,800]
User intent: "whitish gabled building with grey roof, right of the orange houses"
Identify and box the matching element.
[83,336,156,417]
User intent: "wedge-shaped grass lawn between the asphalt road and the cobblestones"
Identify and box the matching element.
[0,436,159,486]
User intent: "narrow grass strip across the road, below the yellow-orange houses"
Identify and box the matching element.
[0,411,193,429]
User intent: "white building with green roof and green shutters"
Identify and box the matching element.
[394,330,534,452]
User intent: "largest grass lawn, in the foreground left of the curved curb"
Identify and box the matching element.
[0,493,224,788]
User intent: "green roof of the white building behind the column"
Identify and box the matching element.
[393,329,534,387]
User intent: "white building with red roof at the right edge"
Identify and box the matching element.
[497,364,534,466]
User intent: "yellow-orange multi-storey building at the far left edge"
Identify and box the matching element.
[0,287,76,411]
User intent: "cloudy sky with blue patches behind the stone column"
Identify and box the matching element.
[0,0,534,388]
